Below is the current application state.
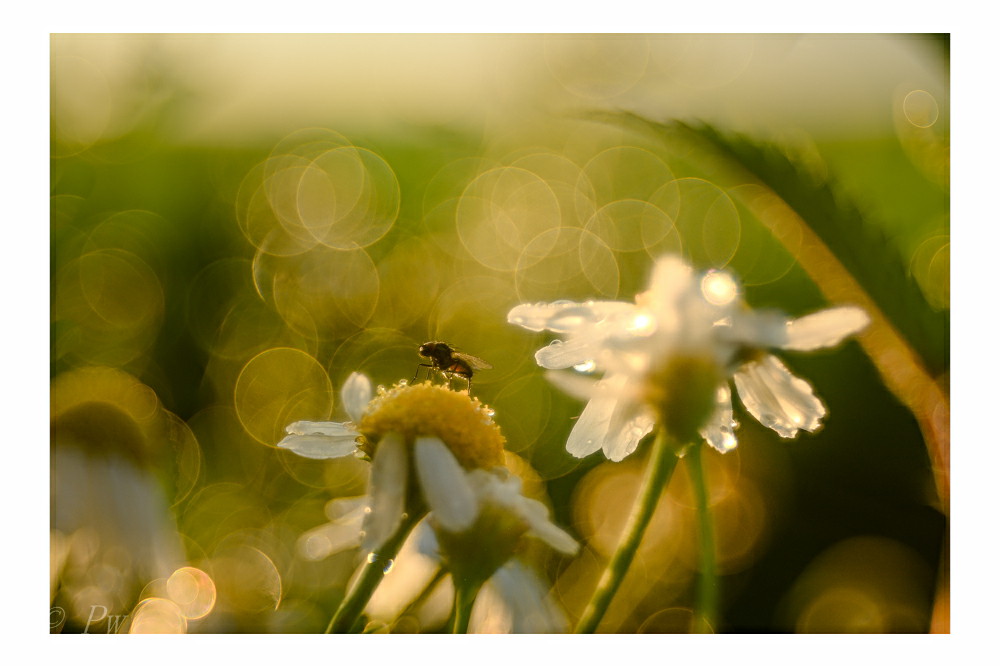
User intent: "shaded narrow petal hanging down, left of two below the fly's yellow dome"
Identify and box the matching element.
[362,432,409,553]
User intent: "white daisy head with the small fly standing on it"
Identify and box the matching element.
[278,373,504,553]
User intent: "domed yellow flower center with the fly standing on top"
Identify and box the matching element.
[358,382,504,469]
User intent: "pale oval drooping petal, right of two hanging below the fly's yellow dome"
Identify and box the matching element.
[413,437,479,532]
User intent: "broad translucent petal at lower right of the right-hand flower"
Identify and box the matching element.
[733,355,826,437]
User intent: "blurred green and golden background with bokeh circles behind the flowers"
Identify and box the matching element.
[51,35,950,632]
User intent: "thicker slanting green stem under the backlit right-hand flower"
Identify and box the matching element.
[575,428,678,634]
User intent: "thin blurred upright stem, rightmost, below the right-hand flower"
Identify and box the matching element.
[687,444,719,634]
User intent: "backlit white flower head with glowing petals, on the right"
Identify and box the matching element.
[507,256,869,461]
